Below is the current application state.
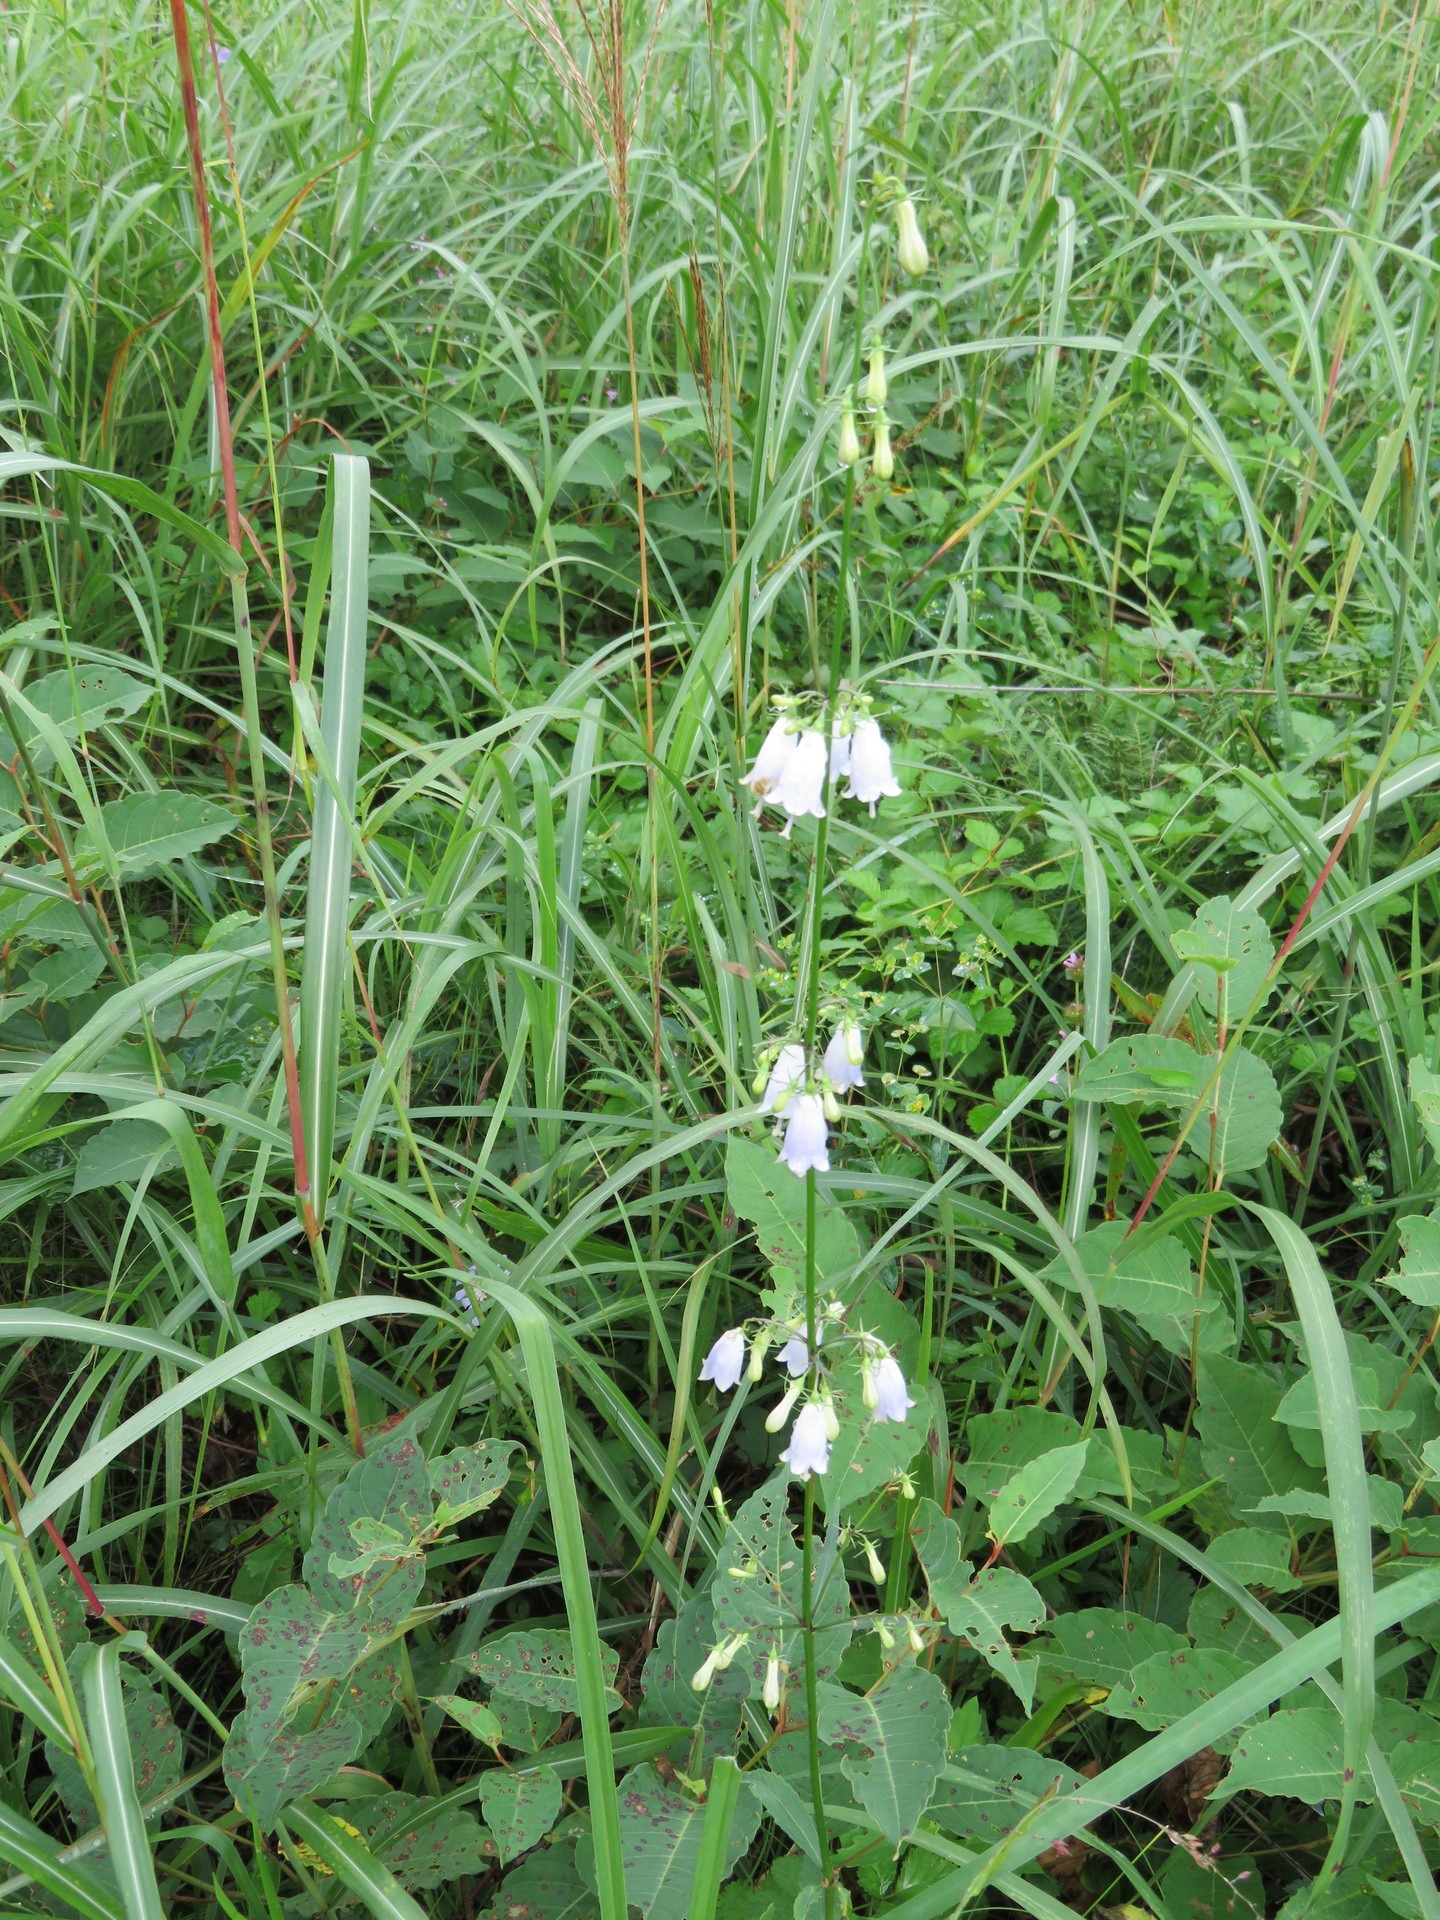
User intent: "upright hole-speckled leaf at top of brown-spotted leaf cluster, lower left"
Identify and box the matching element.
[303,1438,434,1636]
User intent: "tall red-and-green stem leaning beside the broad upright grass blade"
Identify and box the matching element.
[171,0,365,1453]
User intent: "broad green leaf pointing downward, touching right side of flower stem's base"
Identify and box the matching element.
[820,1661,950,1847]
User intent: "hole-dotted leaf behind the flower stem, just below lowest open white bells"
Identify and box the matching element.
[710,1474,852,1699]
